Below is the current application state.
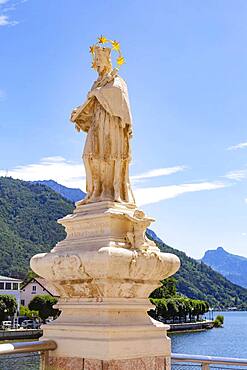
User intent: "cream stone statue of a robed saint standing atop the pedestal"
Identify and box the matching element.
[71,42,135,204]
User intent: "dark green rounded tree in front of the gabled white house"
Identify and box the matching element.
[28,295,59,322]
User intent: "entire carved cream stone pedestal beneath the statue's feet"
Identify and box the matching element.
[31,202,179,370]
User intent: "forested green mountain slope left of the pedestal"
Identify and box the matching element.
[0,177,74,278]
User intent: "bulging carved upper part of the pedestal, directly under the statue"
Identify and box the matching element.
[31,202,180,298]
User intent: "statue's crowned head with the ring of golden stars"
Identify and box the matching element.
[90,36,125,74]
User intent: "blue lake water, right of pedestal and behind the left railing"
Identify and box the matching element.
[0,312,247,370]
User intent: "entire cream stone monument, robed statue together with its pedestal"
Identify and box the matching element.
[31,37,180,370]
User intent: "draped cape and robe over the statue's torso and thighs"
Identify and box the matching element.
[83,76,131,161]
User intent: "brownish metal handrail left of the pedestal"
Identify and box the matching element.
[0,340,57,355]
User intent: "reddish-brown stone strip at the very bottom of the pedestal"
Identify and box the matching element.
[46,356,170,370]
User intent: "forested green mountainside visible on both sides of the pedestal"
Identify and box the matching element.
[0,177,247,309]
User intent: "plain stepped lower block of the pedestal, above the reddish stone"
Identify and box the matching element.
[41,298,170,360]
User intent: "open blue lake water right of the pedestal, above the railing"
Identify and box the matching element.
[169,312,247,359]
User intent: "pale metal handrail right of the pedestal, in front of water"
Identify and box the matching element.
[171,353,247,366]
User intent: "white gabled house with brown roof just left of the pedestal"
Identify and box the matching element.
[21,277,59,306]
